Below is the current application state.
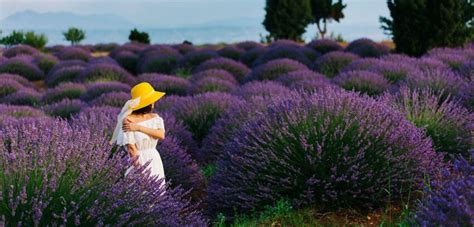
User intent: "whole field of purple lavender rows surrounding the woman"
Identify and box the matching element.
[0,39,474,226]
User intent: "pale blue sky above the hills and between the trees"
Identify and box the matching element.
[0,0,389,42]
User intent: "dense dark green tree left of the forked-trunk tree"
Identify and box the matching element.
[263,0,312,41]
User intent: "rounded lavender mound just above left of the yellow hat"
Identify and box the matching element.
[78,64,135,84]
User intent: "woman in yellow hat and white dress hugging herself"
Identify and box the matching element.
[110,82,165,186]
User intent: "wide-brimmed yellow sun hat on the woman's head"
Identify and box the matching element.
[130,82,166,111]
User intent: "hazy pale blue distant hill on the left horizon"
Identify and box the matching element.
[0,10,135,29]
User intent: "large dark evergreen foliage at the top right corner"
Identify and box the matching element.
[380,0,474,56]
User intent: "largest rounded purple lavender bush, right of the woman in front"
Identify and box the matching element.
[208,89,442,217]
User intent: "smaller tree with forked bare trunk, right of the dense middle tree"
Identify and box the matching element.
[311,0,347,39]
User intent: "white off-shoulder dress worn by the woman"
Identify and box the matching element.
[117,116,165,186]
